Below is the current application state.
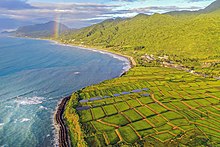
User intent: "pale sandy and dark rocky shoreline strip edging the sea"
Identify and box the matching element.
[49,38,137,147]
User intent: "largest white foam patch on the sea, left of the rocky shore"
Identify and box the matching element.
[15,96,44,105]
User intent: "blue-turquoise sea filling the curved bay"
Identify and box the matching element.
[0,37,128,147]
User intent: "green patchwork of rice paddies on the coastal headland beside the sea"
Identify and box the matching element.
[65,67,220,147]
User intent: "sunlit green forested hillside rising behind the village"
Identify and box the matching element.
[59,0,220,76]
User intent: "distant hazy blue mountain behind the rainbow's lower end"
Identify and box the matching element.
[15,21,70,38]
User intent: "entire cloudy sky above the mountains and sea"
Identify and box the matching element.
[0,0,215,31]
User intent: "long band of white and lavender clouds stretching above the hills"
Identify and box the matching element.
[0,0,206,29]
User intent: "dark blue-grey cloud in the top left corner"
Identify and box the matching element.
[0,0,35,10]
